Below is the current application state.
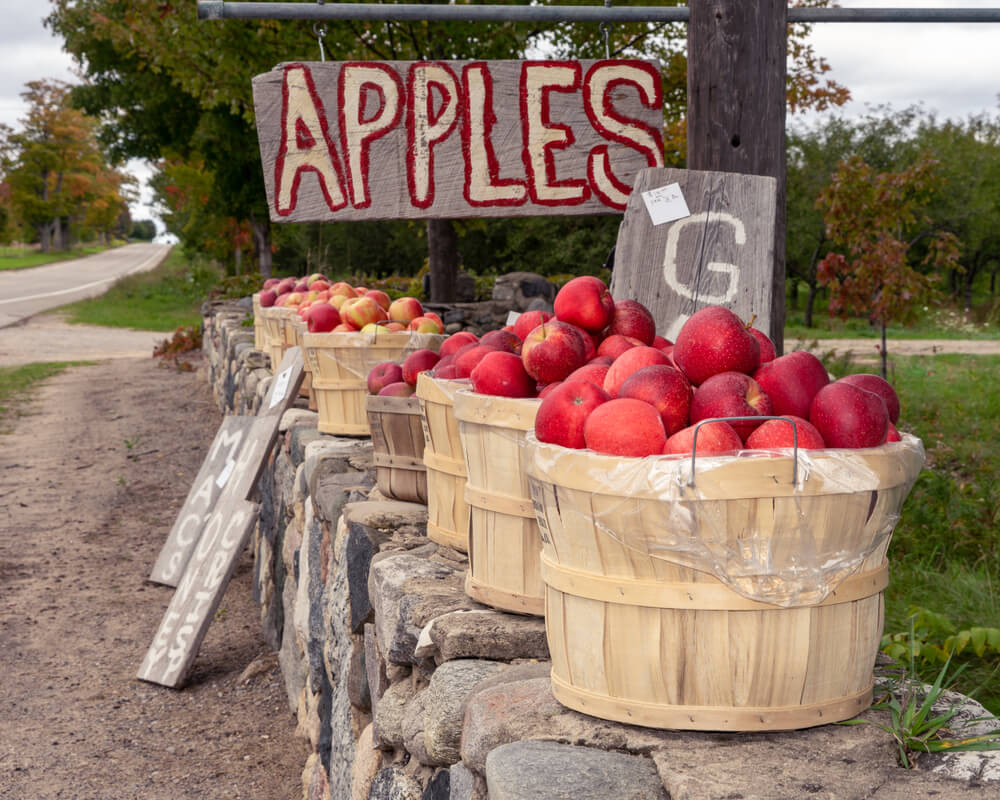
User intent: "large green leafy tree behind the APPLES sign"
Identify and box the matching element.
[49,0,848,288]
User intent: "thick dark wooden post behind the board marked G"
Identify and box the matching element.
[687,0,787,353]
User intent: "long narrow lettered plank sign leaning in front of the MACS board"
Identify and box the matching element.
[136,347,305,688]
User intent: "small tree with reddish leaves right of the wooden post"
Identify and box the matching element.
[817,154,960,376]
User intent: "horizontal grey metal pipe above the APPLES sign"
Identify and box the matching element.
[198,0,1000,23]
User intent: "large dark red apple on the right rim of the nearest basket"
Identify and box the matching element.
[809,380,889,448]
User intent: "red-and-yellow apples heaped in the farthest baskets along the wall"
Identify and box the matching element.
[257,272,444,335]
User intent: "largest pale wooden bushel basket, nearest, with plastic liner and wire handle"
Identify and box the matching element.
[530,436,923,731]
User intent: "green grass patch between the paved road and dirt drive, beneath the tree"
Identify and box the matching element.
[63,248,221,332]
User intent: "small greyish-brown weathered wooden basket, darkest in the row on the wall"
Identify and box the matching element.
[366,395,427,505]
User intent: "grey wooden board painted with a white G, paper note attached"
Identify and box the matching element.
[610,169,777,341]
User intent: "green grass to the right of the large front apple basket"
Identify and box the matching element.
[828,355,1000,714]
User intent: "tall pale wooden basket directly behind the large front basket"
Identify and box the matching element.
[455,390,545,616]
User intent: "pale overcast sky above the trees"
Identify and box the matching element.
[0,0,1000,218]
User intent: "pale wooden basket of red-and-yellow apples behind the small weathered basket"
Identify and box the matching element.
[302,330,444,436]
